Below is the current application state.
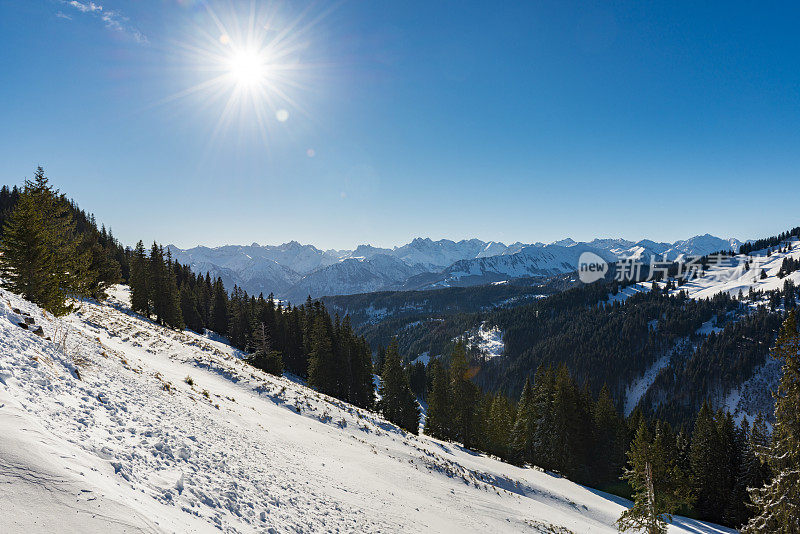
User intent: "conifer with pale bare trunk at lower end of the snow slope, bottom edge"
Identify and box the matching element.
[617,420,690,534]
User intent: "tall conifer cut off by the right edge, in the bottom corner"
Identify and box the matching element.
[742,310,800,534]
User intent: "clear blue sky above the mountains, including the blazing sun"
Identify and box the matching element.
[0,0,800,248]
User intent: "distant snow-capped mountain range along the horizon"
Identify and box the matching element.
[168,234,742,301]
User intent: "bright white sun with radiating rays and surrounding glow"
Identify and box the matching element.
[159,1,330,146]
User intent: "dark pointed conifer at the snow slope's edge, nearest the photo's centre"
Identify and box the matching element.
[378,339,419,434]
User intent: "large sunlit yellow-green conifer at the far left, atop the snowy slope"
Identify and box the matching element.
[0,167,94,315]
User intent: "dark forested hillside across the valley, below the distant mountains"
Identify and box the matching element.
[366,248,796,432]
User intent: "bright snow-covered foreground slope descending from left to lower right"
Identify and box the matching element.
[0,288,728,534]
